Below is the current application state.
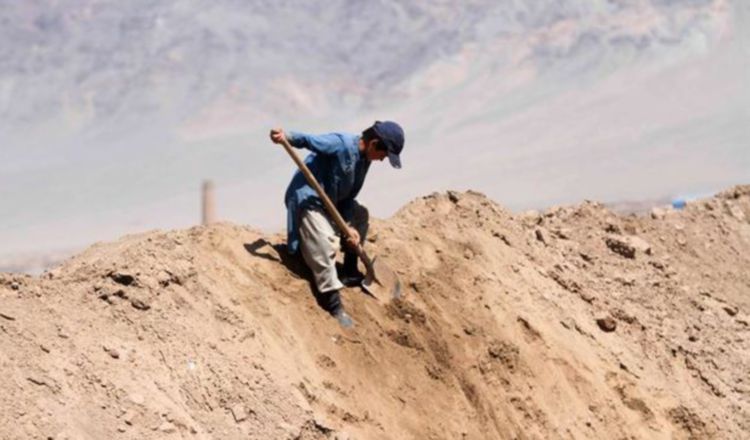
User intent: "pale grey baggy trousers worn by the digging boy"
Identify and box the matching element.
[299,202,370,292]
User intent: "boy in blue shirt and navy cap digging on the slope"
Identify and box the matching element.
[270,121,404,327]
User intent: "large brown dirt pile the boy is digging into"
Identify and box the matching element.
[0,186,750,439]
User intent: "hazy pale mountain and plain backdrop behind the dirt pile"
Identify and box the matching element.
[0,0,750,270]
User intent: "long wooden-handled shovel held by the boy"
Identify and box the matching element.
[281,138,401,298]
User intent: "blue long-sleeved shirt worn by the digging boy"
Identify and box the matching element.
[284,132,370,254]
